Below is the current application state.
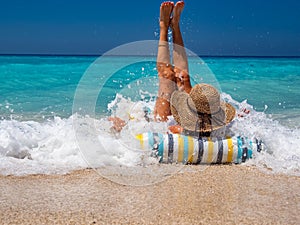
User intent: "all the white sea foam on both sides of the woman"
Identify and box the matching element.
[0,94,300,176]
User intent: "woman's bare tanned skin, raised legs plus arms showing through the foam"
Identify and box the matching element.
[109,1,192,133]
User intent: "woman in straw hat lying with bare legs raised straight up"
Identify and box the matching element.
[110,1,235,136]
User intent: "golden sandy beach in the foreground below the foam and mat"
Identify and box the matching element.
[0,165,300,224]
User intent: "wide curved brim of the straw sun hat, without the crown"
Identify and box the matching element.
[170,91,235,132]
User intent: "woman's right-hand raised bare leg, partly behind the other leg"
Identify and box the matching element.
[170,1,192,93]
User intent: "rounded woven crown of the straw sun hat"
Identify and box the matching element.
[188,84,220,114]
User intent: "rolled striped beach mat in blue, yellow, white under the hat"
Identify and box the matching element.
[136,132,263,164]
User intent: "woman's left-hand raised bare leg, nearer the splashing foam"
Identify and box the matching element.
[154,2,176,121]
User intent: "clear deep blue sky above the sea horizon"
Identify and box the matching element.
[0,0,300,56]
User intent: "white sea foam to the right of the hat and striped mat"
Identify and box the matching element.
[223,94,300,176]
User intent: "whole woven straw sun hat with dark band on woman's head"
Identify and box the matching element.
[170,84,235,132]
